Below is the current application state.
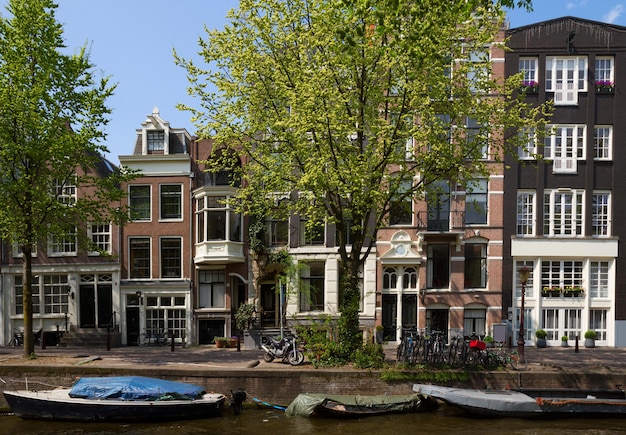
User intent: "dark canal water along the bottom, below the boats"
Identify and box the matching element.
[0,406,626,435]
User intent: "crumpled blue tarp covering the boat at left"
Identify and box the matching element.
[70,376,204,401]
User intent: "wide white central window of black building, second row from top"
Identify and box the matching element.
[544,125,587,173]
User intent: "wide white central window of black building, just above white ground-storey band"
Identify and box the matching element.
[543,190,583,237]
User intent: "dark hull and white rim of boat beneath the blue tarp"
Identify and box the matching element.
[4,389,225,422]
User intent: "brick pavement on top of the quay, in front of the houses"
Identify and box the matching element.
[0,345,626,371]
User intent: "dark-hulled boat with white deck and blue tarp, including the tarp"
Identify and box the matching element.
[3,376,226,422]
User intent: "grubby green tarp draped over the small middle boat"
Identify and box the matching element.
[285,393,424,417]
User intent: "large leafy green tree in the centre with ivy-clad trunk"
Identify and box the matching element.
[174,0,545,358]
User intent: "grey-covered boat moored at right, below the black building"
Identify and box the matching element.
[413,384,626,418]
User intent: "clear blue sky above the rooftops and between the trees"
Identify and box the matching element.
[0,0,626,165]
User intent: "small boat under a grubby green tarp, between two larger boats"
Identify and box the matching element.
[285,393,437,418]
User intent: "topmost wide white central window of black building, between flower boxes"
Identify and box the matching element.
[546,57,587,105]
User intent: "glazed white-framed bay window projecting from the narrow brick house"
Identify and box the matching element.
[196,196,241,242]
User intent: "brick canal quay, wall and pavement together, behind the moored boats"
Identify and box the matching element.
[0,345,626,408]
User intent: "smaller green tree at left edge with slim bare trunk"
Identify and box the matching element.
[0,0,132,357]
